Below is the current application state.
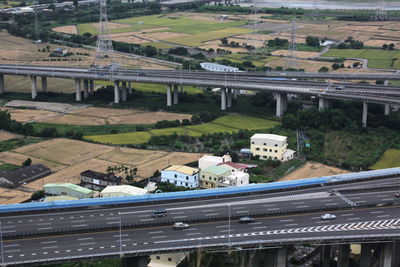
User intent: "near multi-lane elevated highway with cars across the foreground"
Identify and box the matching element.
[0,171,400,267]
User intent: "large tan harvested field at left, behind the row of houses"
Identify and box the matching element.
[0,138,203,204]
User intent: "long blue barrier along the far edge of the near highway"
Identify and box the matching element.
[0,168,400,215]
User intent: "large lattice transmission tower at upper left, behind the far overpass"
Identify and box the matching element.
[94,0,114,68]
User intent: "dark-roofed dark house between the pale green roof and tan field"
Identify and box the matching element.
[81,170,122,191]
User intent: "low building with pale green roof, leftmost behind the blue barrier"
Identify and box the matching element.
[43,183,95,199]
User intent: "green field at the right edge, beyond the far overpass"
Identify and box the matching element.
[323,49,400,69]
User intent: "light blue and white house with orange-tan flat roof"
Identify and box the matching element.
[161,165,199,188]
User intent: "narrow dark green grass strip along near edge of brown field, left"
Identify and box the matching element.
[27,122,152,135]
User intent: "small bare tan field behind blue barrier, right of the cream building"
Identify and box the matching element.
[279,162,348,181]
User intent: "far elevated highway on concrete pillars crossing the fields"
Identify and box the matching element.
[0,65,400,126]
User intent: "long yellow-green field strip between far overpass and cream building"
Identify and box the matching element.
[84,115,279,145]
